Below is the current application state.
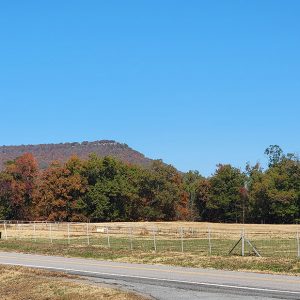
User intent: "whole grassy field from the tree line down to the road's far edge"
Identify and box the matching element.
[0,222,300,275]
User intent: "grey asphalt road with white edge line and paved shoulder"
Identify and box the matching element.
[0,252,300,300]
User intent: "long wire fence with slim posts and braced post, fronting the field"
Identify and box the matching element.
[0,221,300,258]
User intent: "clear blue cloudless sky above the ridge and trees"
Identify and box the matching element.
[0,0,300,175]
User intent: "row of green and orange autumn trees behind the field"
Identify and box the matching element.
[0,145,300,224]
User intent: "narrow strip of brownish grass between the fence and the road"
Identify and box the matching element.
[0,240,300,275]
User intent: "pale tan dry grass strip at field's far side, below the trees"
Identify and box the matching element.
[0,222,299,239]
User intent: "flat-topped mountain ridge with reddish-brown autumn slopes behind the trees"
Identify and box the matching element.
[0,140,152,169]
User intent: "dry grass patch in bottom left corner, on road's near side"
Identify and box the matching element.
[0,265,142,300]
